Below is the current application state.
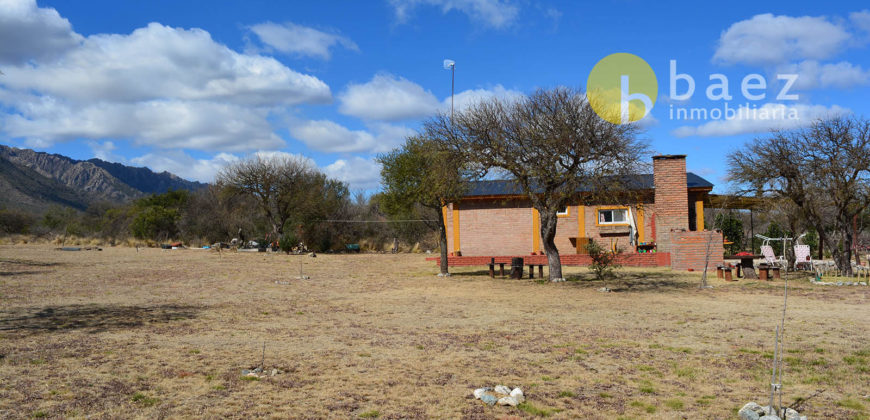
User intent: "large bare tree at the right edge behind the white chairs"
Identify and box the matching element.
[729,117,870,275]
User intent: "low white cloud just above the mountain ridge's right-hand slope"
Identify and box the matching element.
[130,150,239,182]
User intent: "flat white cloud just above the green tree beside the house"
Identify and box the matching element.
[290,120,414,153]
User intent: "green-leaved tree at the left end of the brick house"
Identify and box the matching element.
[378,136,472,275]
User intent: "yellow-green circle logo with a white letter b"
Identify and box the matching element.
[586,53,659,124]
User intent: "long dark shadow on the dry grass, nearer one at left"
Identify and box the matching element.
[0,305,199,333]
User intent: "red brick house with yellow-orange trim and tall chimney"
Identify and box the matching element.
[442,155,724,270]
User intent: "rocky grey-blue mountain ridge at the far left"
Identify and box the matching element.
[0,145,206,213]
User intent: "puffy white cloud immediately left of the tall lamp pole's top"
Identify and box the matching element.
[338,74,438,121]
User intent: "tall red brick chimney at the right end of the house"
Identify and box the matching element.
[653,155,689,252]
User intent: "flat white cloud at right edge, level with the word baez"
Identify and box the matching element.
[779,60,870,89]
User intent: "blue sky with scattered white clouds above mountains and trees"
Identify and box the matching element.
[0,0,870,193]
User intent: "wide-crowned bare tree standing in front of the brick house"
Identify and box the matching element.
[424,87,647,280]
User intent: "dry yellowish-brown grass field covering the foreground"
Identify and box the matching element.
[0,245,870,419]
